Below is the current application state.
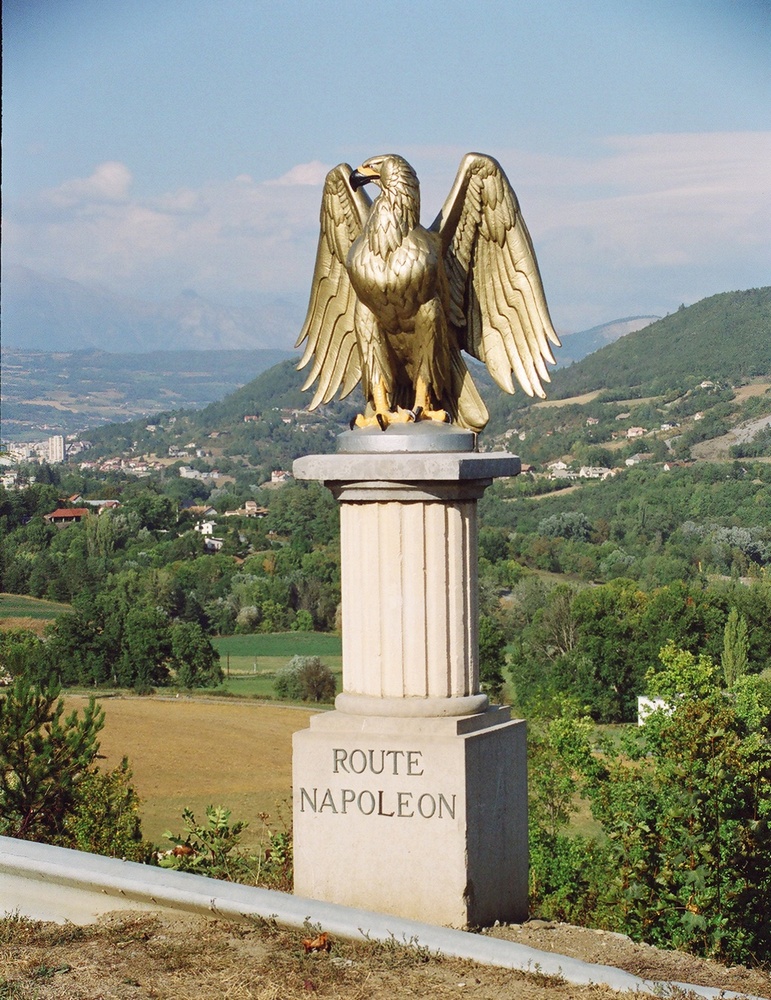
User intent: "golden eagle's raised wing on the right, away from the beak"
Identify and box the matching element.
[431,153,560,397]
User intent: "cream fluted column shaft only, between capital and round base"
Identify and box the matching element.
[340,486,479,698]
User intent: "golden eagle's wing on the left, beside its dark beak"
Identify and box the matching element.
[296,163,371,410]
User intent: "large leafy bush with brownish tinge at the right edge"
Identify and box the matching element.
[587,644,771,963]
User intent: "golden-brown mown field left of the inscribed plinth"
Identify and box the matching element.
[65,696,312,844]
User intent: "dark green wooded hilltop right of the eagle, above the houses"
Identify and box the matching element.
[549,287,771,399]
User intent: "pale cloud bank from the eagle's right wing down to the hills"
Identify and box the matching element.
[482,132,771,330]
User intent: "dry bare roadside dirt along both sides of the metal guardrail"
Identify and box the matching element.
[0,913,771,1000]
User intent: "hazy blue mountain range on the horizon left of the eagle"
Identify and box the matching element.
[2,264,303,353]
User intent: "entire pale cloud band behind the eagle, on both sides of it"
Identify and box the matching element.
[5,133,771,329]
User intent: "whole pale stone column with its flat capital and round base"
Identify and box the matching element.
[295,453,519,716]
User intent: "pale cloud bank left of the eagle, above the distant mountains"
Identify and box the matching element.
[5,164,320,300]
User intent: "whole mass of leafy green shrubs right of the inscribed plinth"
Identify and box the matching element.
[529,643,771,964]
